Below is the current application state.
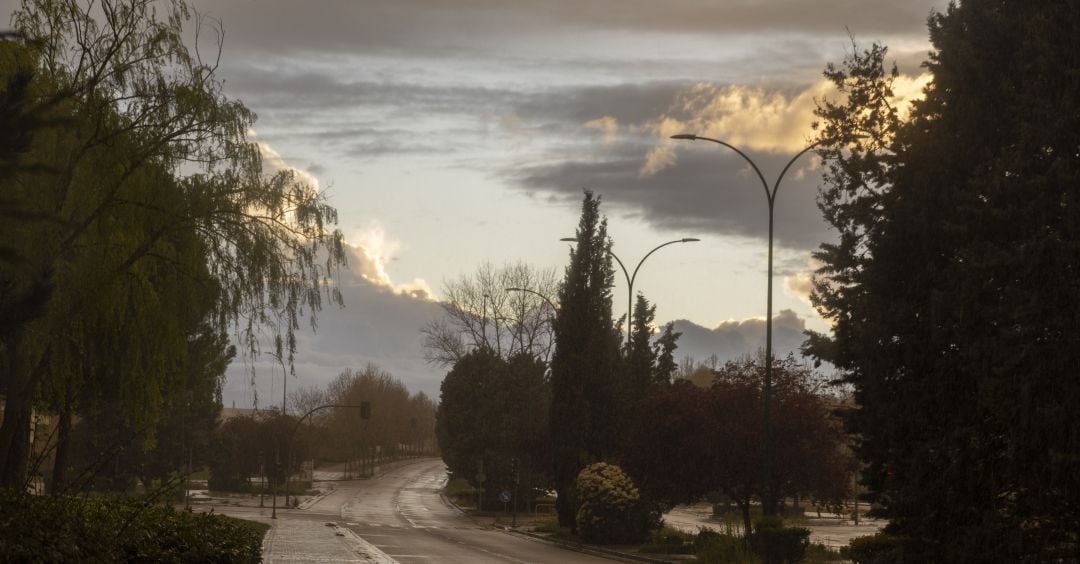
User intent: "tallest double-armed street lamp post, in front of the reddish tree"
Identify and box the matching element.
[672,133,827,515]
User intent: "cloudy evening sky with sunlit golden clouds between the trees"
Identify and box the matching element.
[0,0,945,407]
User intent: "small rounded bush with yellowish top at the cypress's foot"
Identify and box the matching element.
[576,462,659,543]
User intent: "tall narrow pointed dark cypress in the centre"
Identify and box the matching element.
[551,190,622,527]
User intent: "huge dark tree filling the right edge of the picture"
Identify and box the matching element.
[810,0,1080,562]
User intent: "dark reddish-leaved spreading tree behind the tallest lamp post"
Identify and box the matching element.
[625,354,854,534]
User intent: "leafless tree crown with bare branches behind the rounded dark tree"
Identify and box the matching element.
[422,263,558,365]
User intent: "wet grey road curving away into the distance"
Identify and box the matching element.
[206,458,610,564]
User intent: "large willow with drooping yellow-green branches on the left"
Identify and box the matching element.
[0,0,345,485]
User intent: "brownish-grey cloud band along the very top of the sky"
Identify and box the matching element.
[195,0,944,56]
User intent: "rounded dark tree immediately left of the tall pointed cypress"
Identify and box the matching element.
[435,348,551,508]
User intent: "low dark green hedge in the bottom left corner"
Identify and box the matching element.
[0,484,267,563]
